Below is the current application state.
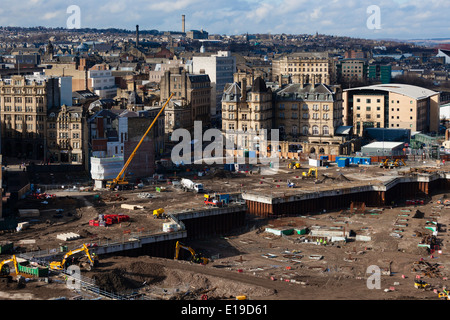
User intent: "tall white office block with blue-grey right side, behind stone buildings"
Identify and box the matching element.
[188,51,236,122]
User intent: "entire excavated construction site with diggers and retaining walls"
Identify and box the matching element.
[0,154,450,300]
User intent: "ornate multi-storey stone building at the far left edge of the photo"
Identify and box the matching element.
[0,74,72,160]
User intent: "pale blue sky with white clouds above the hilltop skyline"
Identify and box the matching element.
[0,0,450,40]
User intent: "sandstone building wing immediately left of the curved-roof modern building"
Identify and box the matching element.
[274,84,346,154]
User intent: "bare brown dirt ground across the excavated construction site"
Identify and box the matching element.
[0,160,450,300]
